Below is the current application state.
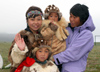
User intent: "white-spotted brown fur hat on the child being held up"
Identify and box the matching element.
[44,5,62,20]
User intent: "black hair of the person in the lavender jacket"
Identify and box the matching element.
[70,3,89,23]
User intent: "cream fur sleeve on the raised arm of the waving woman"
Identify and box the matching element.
[11,43,28,64]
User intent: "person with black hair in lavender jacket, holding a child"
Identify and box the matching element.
[53,4,95,72]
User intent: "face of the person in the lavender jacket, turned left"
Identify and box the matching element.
[69,13,82,27]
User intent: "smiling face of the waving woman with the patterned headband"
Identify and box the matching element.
[27,16,42,30]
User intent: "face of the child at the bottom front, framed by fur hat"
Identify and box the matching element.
[36,48,49,62]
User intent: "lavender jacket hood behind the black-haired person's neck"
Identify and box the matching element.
[80,15,95,32]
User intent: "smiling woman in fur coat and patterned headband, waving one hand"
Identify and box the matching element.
[8,6,43,72]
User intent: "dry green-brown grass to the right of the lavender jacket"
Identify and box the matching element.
[85,43,100,72]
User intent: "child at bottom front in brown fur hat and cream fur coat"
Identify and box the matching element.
[15,39,59,72]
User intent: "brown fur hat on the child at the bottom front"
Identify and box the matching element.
[32,39,51,60]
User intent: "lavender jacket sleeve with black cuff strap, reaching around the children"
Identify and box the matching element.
[53,31,94,65]
